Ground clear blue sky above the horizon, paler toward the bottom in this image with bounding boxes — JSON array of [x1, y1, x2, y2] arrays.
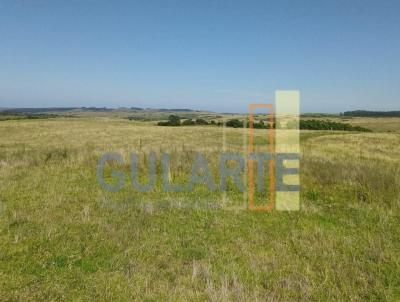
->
[[0, 0, 400, 113]]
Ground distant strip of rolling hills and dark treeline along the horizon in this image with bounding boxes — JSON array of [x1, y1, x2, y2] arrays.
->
[[0, 107, 400, 132]]
